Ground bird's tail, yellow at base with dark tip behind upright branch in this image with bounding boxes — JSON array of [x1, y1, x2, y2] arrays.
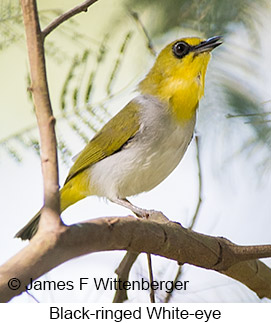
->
[[15, 174, 89, 240]]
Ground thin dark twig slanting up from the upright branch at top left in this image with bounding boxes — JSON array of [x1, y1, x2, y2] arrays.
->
[[42, 0, 98, 38]]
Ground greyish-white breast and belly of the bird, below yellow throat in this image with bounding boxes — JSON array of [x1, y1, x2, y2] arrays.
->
[[90, 96, 195, 199]]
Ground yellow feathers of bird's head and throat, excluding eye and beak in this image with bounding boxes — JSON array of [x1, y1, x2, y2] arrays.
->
[[139, 38, 210, 123]]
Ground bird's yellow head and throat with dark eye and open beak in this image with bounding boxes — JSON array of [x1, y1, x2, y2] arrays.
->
[[139, 36, 222, 118]]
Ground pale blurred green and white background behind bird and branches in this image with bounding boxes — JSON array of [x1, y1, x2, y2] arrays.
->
[[0, 0, 271, 302]]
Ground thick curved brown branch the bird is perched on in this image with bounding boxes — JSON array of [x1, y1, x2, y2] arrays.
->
[[0, 216, 271, 302]]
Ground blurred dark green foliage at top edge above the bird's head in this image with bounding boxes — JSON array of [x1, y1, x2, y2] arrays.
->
[[128, 0, 264, 36]]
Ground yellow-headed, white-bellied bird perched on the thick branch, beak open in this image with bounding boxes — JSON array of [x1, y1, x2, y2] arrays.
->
[[15, 36, 222, 240]]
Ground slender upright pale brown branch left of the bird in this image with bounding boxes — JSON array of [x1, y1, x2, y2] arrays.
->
[[21, 0, 61, 230]]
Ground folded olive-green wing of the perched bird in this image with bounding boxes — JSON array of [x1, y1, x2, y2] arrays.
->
[[65, 101, 139, 184]]
